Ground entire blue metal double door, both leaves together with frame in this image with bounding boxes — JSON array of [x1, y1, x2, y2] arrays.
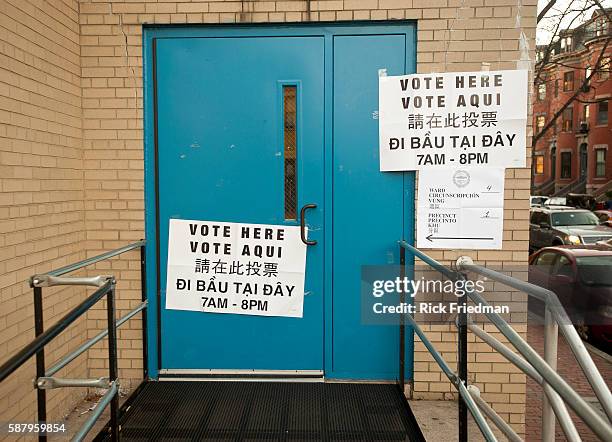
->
[[145, 23, 416, 379]]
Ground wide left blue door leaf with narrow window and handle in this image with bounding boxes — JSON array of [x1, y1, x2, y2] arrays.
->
[[156, 37, 324, 370]]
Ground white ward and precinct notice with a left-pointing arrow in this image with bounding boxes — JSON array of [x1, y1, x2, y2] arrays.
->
[[417, 168, 504, 249]]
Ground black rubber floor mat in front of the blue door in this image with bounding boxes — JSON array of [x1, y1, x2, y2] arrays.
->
[[100, 381, 424, 442]]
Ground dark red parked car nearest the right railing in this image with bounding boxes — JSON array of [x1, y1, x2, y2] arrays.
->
[[529, 245, 612, 345]]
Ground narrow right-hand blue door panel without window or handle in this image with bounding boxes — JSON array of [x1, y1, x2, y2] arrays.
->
[[326, 34, 413, 379]]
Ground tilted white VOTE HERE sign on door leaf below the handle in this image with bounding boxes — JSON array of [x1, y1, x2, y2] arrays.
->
[[166, 219, 306, 318]]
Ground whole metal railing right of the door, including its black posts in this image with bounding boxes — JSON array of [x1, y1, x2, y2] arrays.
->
[[399, 241, 612, 442]]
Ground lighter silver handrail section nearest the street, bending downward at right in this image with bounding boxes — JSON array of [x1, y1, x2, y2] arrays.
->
[[457, 257, 612, 441]]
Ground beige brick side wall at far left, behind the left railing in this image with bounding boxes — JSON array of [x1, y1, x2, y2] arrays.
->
[[0, 0, 91, 428]]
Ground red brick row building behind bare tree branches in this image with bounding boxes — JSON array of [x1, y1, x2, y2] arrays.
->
[[532, 12, 612, 195]]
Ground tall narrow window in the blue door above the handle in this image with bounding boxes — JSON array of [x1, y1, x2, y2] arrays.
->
[[283, 85, 298, 220]]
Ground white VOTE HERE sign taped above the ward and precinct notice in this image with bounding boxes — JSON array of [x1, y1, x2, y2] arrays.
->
[[379, 70, 528, 172]]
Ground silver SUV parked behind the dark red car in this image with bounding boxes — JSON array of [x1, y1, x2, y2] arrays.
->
[[529, 207, 612, 252]]
